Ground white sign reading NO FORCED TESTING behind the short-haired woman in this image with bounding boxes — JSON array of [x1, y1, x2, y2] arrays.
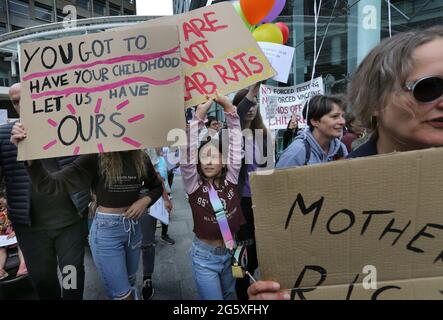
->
[[260, 77, 324, 129]]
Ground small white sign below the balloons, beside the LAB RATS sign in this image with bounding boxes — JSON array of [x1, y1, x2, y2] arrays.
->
[[258, 42, 295, 83]]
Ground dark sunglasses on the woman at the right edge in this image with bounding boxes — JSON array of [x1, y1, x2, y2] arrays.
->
[[406, 76, 443, 103]]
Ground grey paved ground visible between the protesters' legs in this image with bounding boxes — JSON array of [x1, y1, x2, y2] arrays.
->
[[84, 175, 197, 300]]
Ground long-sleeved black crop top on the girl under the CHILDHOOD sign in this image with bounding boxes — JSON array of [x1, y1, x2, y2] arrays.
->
[[27, 152, 163, 208]]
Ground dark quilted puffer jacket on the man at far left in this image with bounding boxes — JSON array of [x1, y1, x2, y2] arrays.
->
[[0, 123, 91, 226]]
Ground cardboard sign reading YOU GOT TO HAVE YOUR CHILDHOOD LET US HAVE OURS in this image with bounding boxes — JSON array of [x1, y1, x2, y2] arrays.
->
[[18, 26, 185, 160]]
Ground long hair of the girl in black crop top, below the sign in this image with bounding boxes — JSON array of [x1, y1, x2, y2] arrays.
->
[[98, 150, 148, 186]]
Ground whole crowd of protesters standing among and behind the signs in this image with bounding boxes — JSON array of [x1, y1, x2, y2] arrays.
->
[[0, 26, 443, 300]]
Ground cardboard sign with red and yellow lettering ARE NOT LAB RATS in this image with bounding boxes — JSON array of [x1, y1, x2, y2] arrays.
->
[[133, 2, 276, 107]]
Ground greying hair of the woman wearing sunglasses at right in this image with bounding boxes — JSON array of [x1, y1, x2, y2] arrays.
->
[[348, 26, 443, 129]]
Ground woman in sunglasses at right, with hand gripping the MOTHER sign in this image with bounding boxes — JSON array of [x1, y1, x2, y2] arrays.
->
[[248, 26, 443, 300]]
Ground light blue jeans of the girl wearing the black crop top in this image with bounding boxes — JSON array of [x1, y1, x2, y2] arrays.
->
[[89, 211, 142, 299]]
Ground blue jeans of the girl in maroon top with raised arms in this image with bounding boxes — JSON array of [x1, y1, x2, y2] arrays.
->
[[190, 237, 235, 300]]
